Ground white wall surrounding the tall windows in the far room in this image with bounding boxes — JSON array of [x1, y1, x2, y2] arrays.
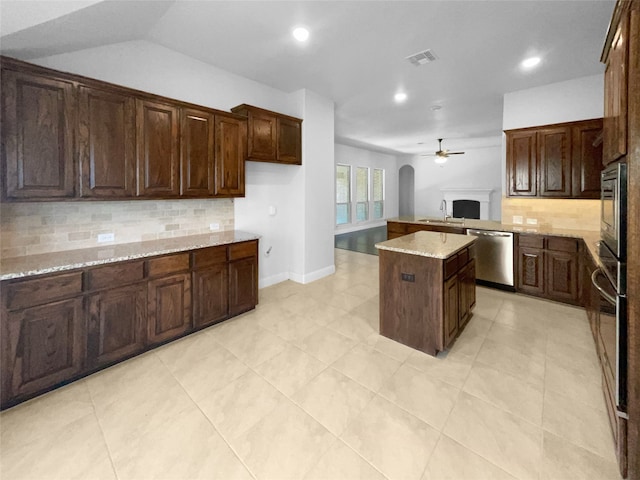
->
[[331, 143, 399, 233]]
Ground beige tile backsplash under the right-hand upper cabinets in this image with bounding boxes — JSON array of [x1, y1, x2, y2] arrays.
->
[[502, 197, 600, 231]]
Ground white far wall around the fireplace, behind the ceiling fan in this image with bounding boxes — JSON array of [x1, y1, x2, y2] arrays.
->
[[408, 144, 502, 220]]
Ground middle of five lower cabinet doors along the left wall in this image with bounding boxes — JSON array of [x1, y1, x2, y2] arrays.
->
[[147, 273, 191, 343]]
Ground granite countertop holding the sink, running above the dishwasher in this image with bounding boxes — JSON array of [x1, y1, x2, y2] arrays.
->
[[387, 215, 601, 266]]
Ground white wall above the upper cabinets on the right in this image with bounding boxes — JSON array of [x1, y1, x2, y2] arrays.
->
[[502, 74, 604, 192]]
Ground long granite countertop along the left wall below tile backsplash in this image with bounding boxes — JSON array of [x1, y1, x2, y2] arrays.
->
[[0, 230, 260, 280]]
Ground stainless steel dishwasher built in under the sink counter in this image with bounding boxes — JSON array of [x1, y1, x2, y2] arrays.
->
[[467, 229, 514, 291]]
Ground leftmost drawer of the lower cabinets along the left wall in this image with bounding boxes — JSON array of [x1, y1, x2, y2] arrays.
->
[[3, 272, 82, 310]]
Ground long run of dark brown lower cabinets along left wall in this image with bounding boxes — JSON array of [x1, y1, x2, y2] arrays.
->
[[0, 240, 258, 408]]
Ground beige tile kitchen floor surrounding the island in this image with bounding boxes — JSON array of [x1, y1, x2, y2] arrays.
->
[[0, 250, 619, 480]]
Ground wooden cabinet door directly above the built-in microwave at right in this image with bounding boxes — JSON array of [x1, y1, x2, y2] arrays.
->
[[603, 13, 629, 165]]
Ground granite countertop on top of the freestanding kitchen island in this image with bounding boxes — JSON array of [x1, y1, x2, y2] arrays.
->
[[376, 232, 476, 260]]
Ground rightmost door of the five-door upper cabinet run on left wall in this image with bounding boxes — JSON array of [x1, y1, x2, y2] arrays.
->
[[215, 115, 247, 197]]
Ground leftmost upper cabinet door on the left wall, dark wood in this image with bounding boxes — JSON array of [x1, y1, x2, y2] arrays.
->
[[2, 70, 75, 199]]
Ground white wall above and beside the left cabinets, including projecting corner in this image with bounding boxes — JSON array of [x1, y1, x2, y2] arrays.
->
[[33, 41, 334, 287]]
